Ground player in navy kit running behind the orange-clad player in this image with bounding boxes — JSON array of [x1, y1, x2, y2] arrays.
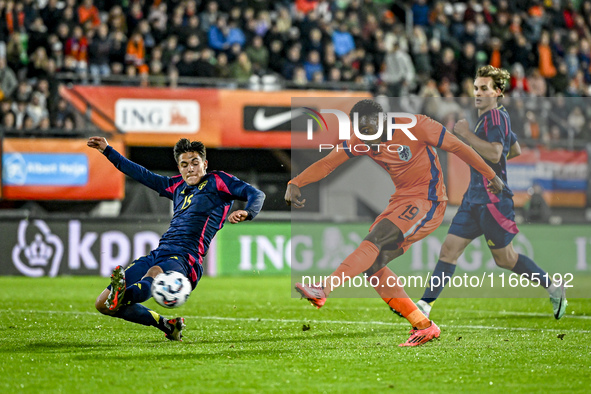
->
[[417, 66, 567, 319]]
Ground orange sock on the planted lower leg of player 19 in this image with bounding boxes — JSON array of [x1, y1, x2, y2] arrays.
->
[[368, 267, 431, 329]]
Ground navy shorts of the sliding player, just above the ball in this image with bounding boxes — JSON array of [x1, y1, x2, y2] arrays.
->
[[107, 249, 203, 289]]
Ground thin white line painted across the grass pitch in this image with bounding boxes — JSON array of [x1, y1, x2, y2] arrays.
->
[[0, 309, 591, 334]]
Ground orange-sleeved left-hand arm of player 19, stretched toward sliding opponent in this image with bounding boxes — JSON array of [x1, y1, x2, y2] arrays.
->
[[285, 145, 349, 208]]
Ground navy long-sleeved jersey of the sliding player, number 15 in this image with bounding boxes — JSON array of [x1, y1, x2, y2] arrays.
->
[[104, 146, 265, 263]]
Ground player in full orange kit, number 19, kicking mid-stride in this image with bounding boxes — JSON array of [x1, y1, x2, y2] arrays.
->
[[285, 99, 504, 346]]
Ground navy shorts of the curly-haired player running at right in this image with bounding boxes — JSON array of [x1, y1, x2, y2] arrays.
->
[[448, 198, 519, 249]]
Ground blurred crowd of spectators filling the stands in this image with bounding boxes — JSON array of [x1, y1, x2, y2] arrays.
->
[[0, 0, 591, 140]]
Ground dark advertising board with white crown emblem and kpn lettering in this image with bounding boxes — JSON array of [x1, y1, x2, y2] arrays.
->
[[0, 219, 169, 277]]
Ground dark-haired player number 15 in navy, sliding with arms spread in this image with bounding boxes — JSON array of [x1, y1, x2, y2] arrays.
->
[[87, 137, 265, 341]]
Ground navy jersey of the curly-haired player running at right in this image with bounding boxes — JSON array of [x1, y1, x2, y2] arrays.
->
[[465, 106, 517, 204]]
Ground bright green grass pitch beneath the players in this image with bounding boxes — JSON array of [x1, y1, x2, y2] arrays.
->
[[0, 277, 591, 393]]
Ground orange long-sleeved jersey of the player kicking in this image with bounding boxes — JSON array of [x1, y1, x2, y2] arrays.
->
[[290, 115, 495, 201]]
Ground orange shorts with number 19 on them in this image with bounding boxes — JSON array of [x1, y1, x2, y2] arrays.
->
[[369, 197, 447, 252]]
